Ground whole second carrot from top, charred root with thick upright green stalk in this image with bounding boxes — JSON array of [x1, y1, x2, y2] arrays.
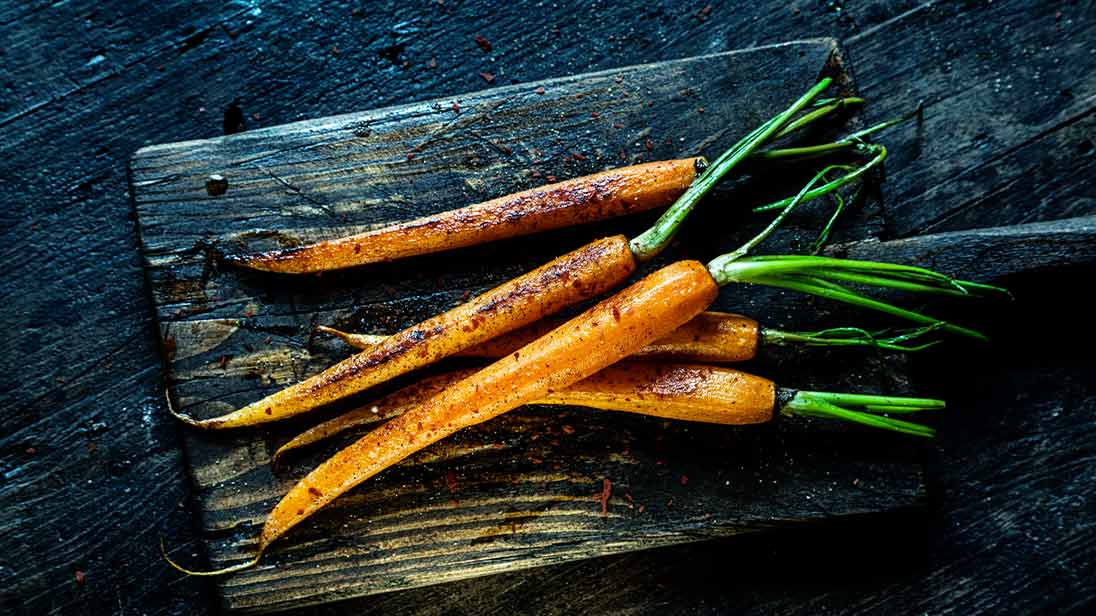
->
[[172, 78, 831, 429]]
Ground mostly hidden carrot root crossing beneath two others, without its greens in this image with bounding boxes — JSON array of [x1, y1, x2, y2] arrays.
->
[[317, 311, 761, 363]]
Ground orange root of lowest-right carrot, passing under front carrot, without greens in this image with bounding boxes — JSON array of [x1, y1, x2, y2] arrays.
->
[[273, 362, 776, 460]]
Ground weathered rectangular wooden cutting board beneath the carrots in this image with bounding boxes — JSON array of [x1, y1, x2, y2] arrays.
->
[[130, 39, 923, 611]]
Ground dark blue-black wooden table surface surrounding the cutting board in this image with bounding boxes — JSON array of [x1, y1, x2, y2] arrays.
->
[[0, 0, 1096, 614]]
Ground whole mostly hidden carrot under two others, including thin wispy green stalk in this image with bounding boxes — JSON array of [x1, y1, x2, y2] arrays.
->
[[316, 311, 937, 363]]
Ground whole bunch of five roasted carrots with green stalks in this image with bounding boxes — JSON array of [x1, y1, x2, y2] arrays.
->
[[168, 79, 1006, 575]]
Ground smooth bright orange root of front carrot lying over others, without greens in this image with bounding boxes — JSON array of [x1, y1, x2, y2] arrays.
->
[[259, 261, 719, 554]]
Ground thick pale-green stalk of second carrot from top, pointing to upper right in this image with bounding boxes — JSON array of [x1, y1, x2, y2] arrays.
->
[[630, 78, 832, 261]]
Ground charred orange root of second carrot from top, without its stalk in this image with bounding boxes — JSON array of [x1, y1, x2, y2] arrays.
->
[[176, 236, 636, 429]]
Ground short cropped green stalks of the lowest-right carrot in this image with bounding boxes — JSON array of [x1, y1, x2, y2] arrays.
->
[[780, 391, 945, 437]]
